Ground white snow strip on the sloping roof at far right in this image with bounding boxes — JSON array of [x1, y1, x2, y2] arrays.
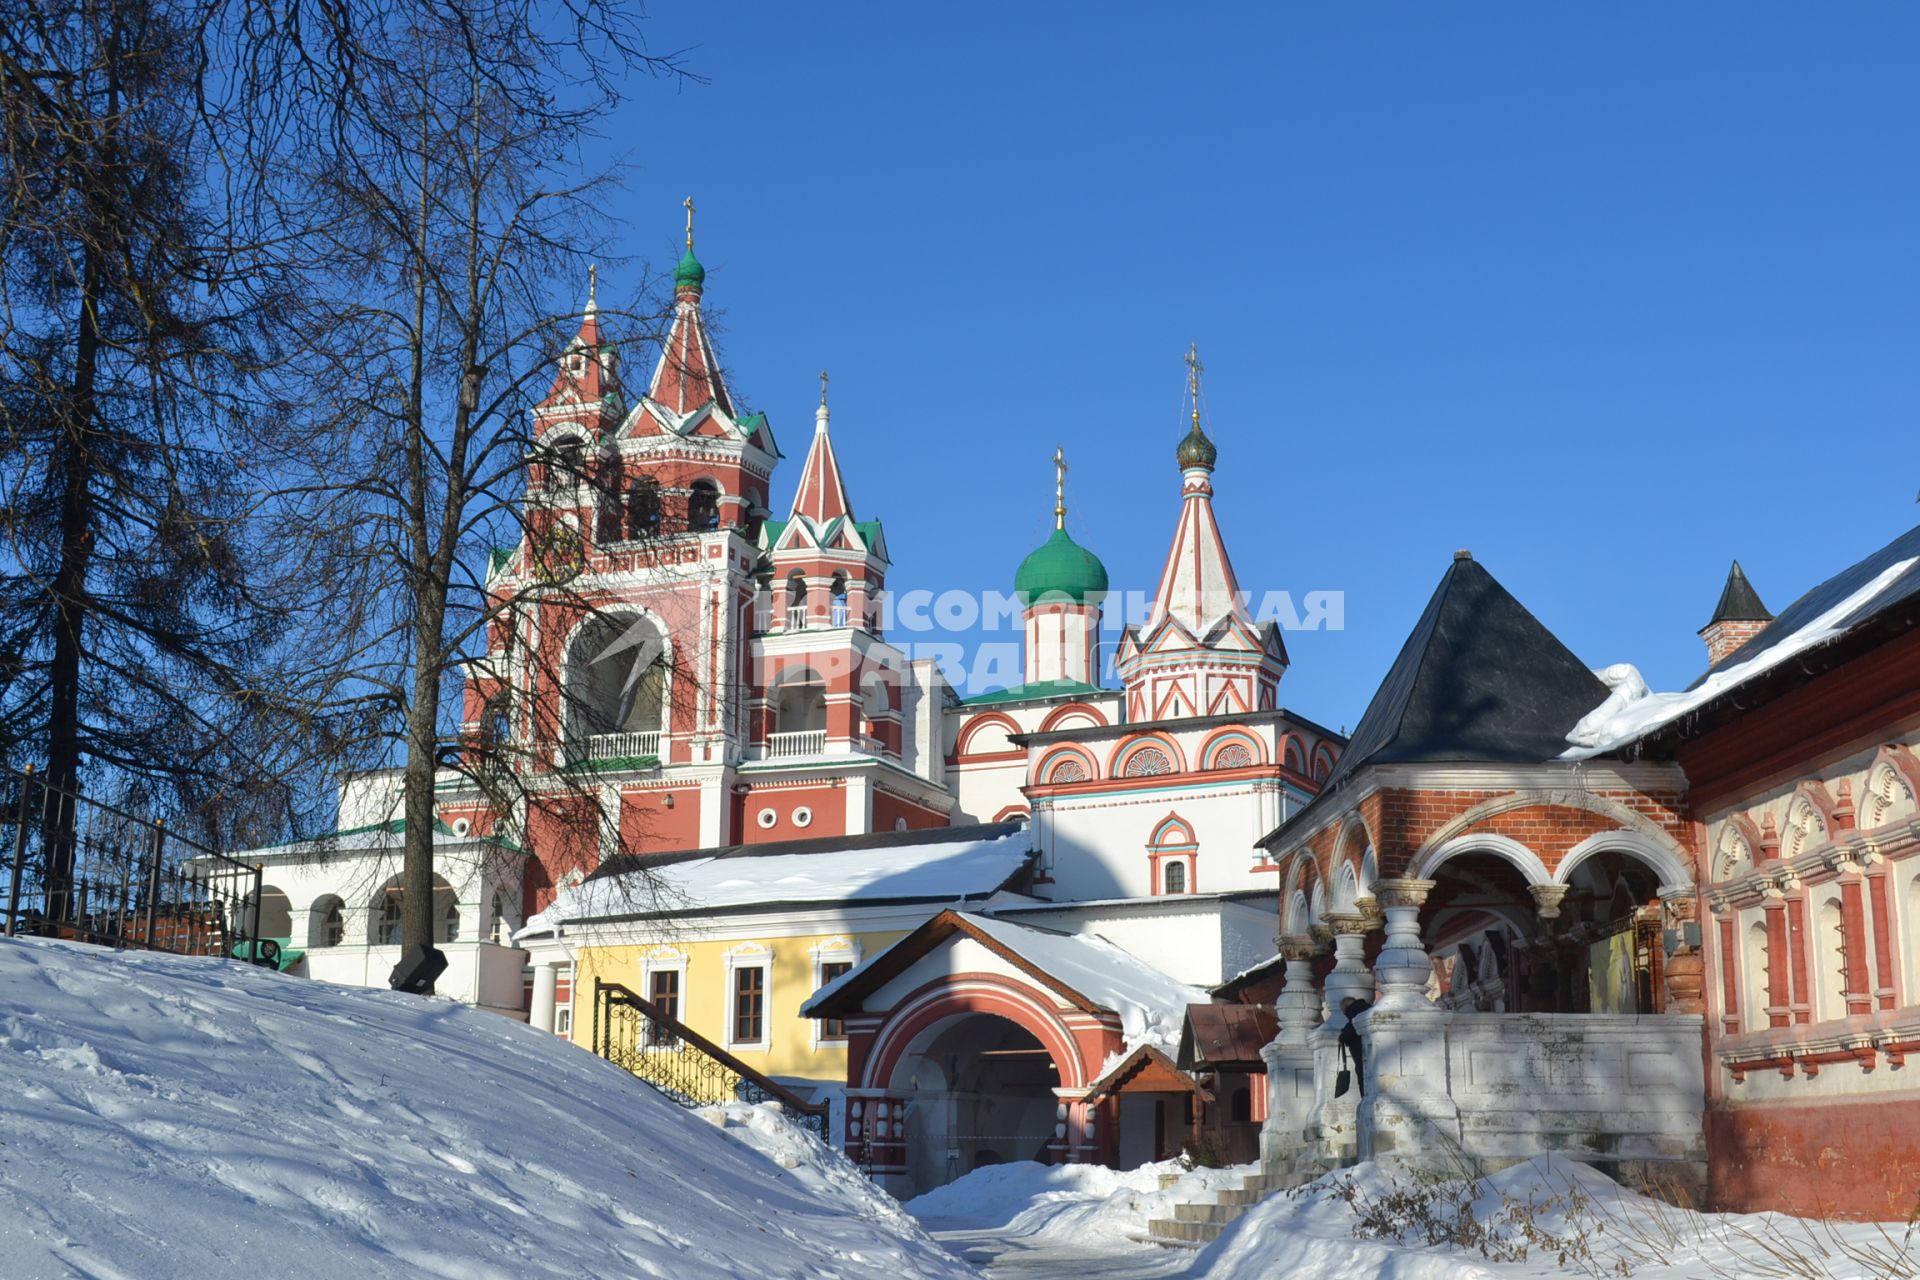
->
[[1561, 557, 1920, 760]]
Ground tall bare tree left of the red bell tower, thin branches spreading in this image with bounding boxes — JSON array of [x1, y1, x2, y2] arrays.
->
[[245, 0, 698, 946]]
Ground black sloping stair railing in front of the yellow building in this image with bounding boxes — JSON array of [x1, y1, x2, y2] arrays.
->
[[593, 979, 828, 1142]]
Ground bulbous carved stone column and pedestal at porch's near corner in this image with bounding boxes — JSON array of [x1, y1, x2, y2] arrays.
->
[[1356, 879, 1461, 1169]]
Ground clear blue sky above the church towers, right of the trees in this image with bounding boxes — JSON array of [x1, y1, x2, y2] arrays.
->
[[576, 0, 1920, 725]]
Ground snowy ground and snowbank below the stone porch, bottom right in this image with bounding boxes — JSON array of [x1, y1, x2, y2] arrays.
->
[[906, 1157, 1920, 1280]]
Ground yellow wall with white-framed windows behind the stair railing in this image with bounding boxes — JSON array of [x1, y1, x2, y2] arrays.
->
[[570, 931, 904, 1084]]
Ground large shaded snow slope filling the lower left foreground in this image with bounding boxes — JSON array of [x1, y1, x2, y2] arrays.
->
[[0, 940, 975, 1280]]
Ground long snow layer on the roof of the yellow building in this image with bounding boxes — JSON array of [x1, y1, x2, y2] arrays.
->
[[516, 827, 1029, 936]]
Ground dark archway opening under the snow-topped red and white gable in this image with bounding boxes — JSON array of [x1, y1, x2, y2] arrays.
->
[[887, 1013, 1060, 1196]]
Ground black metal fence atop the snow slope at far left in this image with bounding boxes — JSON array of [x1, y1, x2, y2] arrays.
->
[[0, 770, 264, 963]]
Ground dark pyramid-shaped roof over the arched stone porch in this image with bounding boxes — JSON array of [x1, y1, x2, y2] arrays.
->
[[1302, 551, 1607, 812]]
